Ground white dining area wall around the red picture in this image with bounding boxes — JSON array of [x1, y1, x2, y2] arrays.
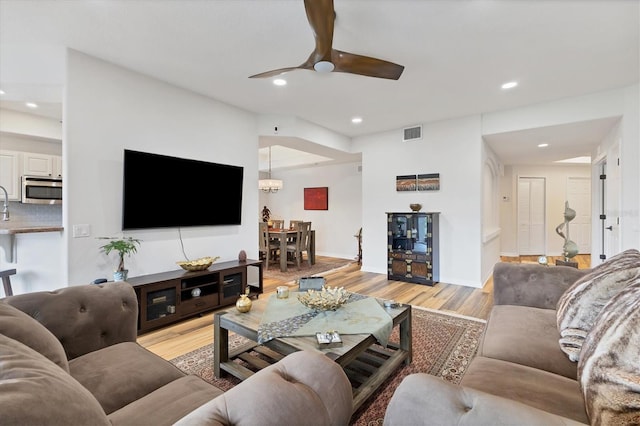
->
[[256, 163, 363, 259]]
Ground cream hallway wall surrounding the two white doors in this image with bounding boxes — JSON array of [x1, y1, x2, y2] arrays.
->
[[500, 165, 593, 256]]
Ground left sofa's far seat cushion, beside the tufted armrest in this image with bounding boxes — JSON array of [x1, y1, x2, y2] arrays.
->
[[69, 342, 185, 414]]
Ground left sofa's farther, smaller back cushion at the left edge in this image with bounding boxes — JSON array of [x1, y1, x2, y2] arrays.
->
[[0, 302, 69, 373]]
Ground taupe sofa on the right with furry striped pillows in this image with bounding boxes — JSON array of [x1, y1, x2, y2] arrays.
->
[[384, 250, 640, 426]]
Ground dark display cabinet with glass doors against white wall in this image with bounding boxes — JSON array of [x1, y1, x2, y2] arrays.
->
[[387, 212, 440, 285]]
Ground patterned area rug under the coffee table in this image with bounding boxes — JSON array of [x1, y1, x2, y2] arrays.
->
[[171, 307, 485, 426]]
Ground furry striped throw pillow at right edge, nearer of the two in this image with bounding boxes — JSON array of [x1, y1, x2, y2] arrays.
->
[[578, 278, 640, 425]]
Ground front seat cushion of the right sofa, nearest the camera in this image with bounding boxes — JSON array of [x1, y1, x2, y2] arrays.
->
[[462, 356, 588, 423]]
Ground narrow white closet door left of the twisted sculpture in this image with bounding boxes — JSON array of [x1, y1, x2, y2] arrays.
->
[[518, 177, 546, 255]]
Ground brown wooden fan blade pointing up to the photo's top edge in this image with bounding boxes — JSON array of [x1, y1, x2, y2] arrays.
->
[[304, 0, 336, 63]]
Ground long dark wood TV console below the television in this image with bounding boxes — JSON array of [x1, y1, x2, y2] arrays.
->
[[127, 260, 263, 334]]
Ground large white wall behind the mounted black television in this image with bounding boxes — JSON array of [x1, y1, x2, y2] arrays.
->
[[61, 50, 258, 288]]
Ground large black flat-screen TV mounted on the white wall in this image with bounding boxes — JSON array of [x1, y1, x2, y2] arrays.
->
[[122, 149, 244, 230]]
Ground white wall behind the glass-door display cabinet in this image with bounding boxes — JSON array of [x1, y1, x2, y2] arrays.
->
[[353, 116, 482, 287]]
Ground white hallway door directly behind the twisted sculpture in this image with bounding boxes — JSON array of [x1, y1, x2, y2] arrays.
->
[[567, 177, 591, 254]]
